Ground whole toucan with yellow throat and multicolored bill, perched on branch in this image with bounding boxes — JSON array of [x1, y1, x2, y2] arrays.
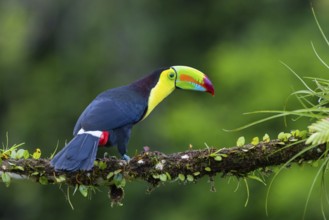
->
[[50, 66, 215, 172]]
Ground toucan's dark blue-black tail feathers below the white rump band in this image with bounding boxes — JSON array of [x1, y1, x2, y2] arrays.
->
[[50, 133, 99, 171]]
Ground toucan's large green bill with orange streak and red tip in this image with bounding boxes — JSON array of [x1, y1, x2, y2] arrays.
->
[[171, 66, 215, 95]]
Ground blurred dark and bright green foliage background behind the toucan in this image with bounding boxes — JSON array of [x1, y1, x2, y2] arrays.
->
[[0, 0, 329, 220]]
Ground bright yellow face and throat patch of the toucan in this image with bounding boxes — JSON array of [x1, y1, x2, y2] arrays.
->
[[142, 69, 176, 120]]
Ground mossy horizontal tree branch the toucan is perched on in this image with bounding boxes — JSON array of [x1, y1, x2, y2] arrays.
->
[[0, 137, 326, 205]]
